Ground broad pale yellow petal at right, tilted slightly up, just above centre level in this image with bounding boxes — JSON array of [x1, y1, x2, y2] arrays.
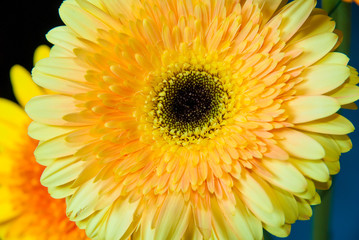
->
[[296, 64, 350, 95]]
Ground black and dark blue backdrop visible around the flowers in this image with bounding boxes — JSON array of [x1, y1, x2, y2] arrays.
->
[[0, 0, 359, 240]]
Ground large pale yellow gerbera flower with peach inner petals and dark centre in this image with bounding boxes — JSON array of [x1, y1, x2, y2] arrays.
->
[[26, 0, 359, 240]]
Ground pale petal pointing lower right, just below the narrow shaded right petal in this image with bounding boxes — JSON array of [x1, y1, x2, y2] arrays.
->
[[275, 129, 325, 160]]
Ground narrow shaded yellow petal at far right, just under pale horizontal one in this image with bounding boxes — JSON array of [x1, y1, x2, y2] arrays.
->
[[295, 114, 354, 135]]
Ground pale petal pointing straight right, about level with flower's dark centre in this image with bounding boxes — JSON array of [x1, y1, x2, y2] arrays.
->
[[283, 96, 340, 123]]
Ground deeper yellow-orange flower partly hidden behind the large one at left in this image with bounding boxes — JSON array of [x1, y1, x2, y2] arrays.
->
[[0, 46, 87, 240]]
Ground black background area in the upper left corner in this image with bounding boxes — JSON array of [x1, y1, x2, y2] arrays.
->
[[0, 0, 63, 100]]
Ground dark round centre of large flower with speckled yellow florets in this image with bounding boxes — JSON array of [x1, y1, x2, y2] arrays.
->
[[147, 67, 230, 145]]
